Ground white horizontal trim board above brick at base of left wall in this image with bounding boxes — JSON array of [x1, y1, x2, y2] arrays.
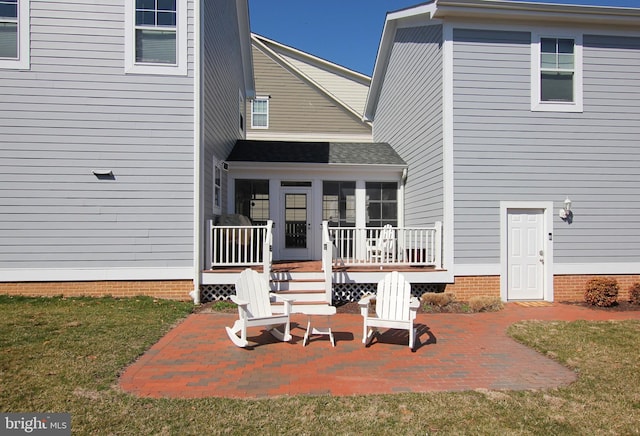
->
[[0, 266, 193, 282]]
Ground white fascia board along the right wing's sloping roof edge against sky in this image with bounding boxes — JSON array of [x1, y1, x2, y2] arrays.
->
[[363, 3, 436, 121]]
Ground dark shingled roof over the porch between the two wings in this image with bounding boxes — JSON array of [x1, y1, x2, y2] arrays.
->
[[227, 139, 407, 168]]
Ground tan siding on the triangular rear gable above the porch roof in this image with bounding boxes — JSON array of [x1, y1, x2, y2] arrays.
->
[[247, 46, 371, 134]]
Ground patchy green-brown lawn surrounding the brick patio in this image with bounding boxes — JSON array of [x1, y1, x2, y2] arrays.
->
[[0, 297, 640, 435]]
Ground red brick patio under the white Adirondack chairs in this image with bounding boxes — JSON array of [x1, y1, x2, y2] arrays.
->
[[120, 304, 640, 398]]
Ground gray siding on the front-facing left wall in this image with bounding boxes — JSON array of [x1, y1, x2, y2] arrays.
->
[[0, 0, 194, 270]]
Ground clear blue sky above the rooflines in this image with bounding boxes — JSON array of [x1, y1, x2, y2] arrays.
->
[[249, 0, 640, 75]]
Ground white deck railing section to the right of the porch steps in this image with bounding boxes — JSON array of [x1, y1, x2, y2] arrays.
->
[[323, 222, 442, 269]]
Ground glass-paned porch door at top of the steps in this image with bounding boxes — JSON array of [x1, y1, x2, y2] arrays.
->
[[278, 187, 314, 260]]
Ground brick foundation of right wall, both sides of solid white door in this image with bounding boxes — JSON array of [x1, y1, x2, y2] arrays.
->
[[445, 275, 640, 302]]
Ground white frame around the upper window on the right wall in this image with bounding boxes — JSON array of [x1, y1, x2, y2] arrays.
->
[[531, 31, 583, 112]]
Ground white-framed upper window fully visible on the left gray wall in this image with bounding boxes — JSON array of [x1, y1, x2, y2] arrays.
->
[[125, 0, 187, 75]]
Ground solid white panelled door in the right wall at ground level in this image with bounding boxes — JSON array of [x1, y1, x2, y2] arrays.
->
[[507, 209, 545, 300]]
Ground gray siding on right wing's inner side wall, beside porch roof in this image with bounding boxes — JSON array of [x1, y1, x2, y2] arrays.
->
[[373, 26, 443, 226]]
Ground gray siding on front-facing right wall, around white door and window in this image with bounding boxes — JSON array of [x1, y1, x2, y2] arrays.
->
[[454, 29, 640, 264]]
